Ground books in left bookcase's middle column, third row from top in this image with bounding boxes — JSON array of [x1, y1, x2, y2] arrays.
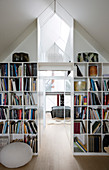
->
[[10, 93, 22, 105]]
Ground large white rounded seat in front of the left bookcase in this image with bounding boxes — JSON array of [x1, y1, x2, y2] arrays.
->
[[0, 142, 33, 168]]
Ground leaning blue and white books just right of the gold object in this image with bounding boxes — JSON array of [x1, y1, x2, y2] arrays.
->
[[89, 79, 101, 91]]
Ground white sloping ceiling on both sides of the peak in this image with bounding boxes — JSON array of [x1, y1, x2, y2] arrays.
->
[[0, 0, 109, 58]]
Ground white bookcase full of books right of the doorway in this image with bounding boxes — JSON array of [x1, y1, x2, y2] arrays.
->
[[73, 62, 109, 155]]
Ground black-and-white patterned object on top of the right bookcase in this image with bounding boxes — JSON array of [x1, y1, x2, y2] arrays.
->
[[77, 52, 99, 62]]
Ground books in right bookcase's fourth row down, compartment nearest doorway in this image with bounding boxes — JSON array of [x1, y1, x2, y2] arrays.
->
[[74, 107, 87, 119]]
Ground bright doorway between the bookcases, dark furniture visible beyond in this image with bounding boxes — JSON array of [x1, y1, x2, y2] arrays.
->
[[39, 66, 72, 145]]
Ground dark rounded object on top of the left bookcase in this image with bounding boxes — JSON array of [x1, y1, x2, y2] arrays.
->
[[12, 52, 29, 62]]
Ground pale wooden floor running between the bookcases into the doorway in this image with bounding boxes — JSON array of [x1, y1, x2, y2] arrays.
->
[[0, 113, 109, 170]]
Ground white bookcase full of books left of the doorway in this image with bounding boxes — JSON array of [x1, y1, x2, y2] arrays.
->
[[0, 62, 38, 155]]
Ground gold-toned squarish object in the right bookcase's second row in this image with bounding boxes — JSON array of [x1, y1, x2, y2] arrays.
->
[[74, 81, 86, 91]]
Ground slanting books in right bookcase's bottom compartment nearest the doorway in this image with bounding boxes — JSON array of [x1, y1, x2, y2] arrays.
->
[[74, 136, 87, 152]]
